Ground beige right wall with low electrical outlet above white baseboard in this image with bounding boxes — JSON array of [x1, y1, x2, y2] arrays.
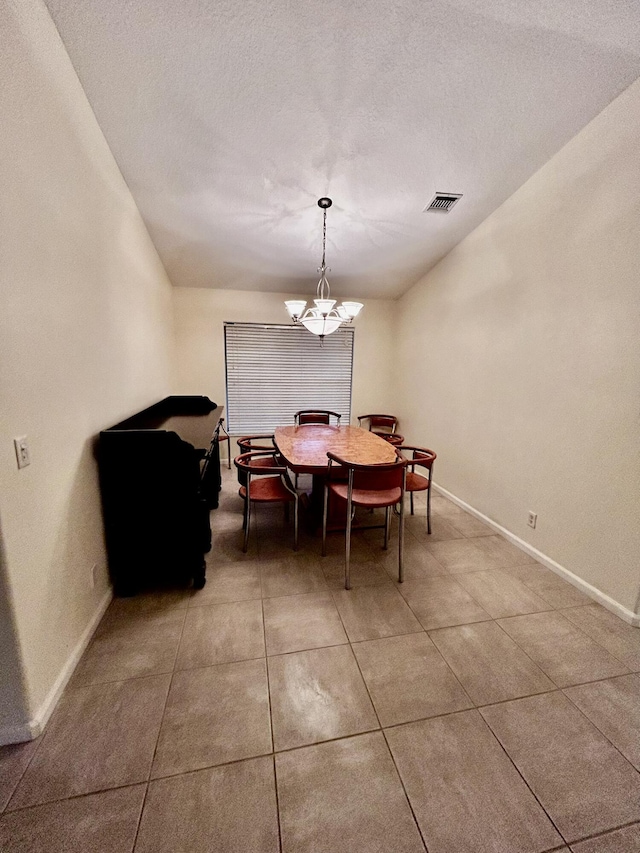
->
[[396, 81, 640, 618]]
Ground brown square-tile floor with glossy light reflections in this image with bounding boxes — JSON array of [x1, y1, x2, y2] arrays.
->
[[0, 469, 640, 853]]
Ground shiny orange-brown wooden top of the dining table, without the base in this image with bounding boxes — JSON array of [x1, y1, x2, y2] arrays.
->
[[274, 424, 396, 474]]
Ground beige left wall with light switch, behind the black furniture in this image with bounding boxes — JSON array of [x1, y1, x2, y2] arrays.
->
[[0, 0, 173, 739]]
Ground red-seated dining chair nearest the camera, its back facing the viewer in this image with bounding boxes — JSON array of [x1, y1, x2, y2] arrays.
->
[[322, 452, 407, 589]]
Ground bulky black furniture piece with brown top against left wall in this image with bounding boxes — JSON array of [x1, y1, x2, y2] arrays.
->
[[98, 396, 223, 595]]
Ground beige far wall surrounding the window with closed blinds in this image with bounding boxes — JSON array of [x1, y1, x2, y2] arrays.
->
[[173, 288, 395, 442]]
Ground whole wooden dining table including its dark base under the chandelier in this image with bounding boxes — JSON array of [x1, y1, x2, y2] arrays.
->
[[274, 424, 397, 530]]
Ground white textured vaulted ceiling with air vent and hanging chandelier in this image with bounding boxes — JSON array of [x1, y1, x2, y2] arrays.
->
[[47, 0, 640, 297]]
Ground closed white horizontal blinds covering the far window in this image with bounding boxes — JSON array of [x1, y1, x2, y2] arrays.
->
[[224, 323, 354, 435]]
